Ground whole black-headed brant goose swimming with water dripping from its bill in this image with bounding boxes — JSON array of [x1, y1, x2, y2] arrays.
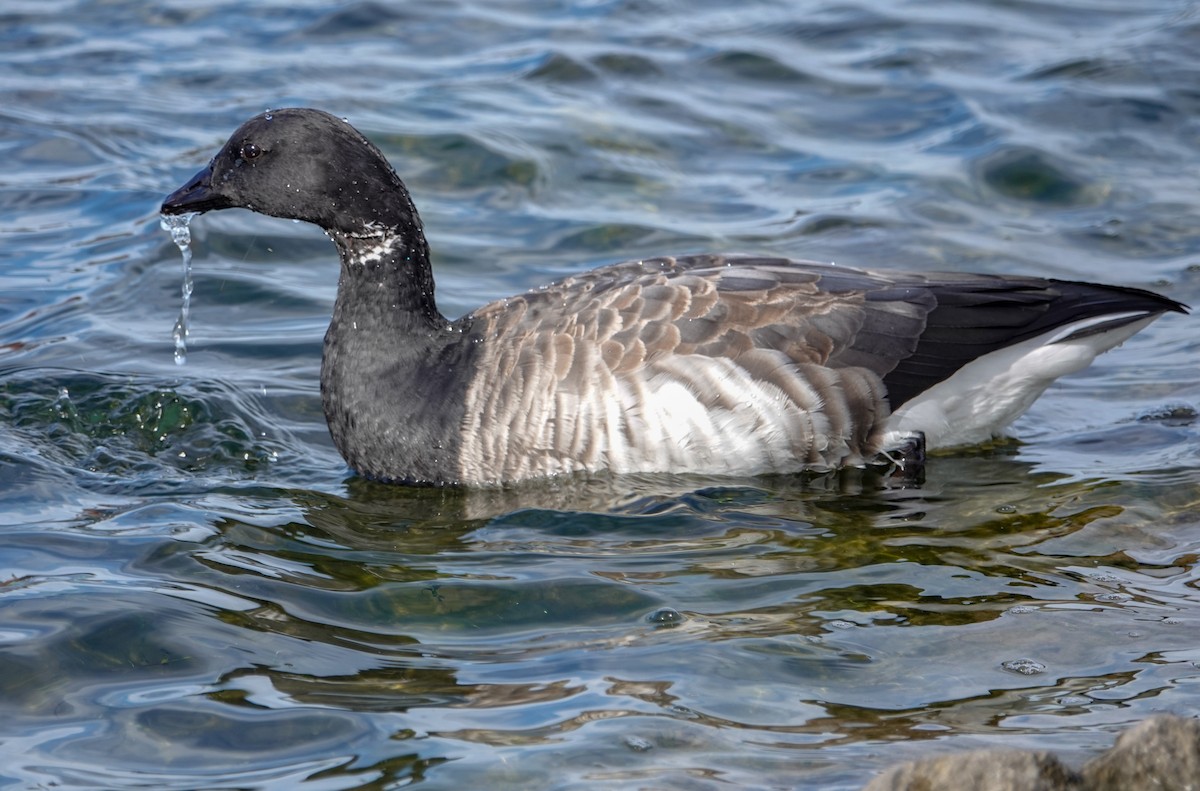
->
[[162, 109, 1187, 486]]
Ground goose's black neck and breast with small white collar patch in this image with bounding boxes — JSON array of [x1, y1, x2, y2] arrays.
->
[[320, 220, 478, 484]]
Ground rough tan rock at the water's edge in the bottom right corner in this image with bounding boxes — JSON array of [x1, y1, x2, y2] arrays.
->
[[863, 715, 1200, 791]]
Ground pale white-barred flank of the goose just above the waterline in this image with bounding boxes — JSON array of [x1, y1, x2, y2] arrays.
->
[[453, 352, 862, 483]]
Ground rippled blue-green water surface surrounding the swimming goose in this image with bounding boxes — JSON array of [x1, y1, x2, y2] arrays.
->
[[0, 0, 1200, 791]]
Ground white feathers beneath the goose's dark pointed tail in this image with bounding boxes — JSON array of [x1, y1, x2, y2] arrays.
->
[[883, 314, 1158, 449]]
